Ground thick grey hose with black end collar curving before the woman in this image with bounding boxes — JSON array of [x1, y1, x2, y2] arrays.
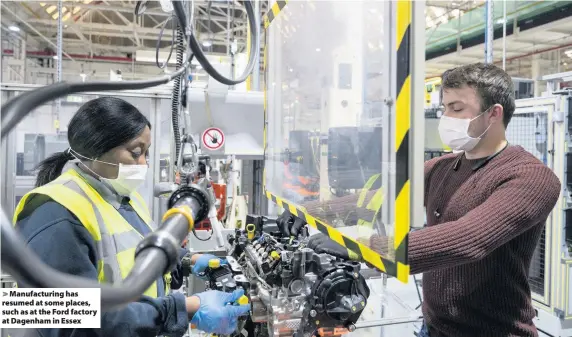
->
[[0, 181, 210, 312]]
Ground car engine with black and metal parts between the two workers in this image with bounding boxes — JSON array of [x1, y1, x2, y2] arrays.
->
[[206, 222, 370, 337]]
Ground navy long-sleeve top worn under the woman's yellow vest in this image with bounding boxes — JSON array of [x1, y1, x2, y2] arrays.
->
[[16, 168, 189, 337]]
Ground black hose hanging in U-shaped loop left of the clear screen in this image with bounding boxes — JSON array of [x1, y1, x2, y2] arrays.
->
[[173, 0, 260, 85]]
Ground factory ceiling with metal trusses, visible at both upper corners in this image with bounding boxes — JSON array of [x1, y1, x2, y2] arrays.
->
[[1, 0, 572, 77]]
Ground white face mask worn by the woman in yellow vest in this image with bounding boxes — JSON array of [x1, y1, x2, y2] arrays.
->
[[70, 150, 148, 196]]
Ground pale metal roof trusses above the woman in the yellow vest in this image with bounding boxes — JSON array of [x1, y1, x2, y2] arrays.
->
[[2, 0, 268, 56]]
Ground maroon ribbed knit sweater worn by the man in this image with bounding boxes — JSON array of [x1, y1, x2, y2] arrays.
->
[[409, 146, 561, 337]]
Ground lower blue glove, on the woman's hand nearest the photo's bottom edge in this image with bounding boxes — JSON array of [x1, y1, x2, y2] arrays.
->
[[191, 289, 250, 335]]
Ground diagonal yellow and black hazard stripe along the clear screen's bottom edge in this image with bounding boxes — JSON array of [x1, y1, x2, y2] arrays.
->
[[265, 191, 398, 276]]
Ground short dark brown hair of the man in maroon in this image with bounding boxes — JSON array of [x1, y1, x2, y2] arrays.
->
[[441, 63, 515, 128]]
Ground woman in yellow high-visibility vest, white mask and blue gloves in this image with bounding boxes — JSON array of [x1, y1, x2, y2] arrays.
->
[[14, 97, 249, 337]]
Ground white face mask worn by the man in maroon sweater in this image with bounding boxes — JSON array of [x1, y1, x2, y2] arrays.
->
[[439, 109, 492, 151]]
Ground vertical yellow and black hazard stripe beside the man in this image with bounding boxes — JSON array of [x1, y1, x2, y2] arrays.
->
[[394, 0, 413, 282]]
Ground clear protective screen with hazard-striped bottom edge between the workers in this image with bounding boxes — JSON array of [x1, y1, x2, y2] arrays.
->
[[264, 1, 409, 275]]
